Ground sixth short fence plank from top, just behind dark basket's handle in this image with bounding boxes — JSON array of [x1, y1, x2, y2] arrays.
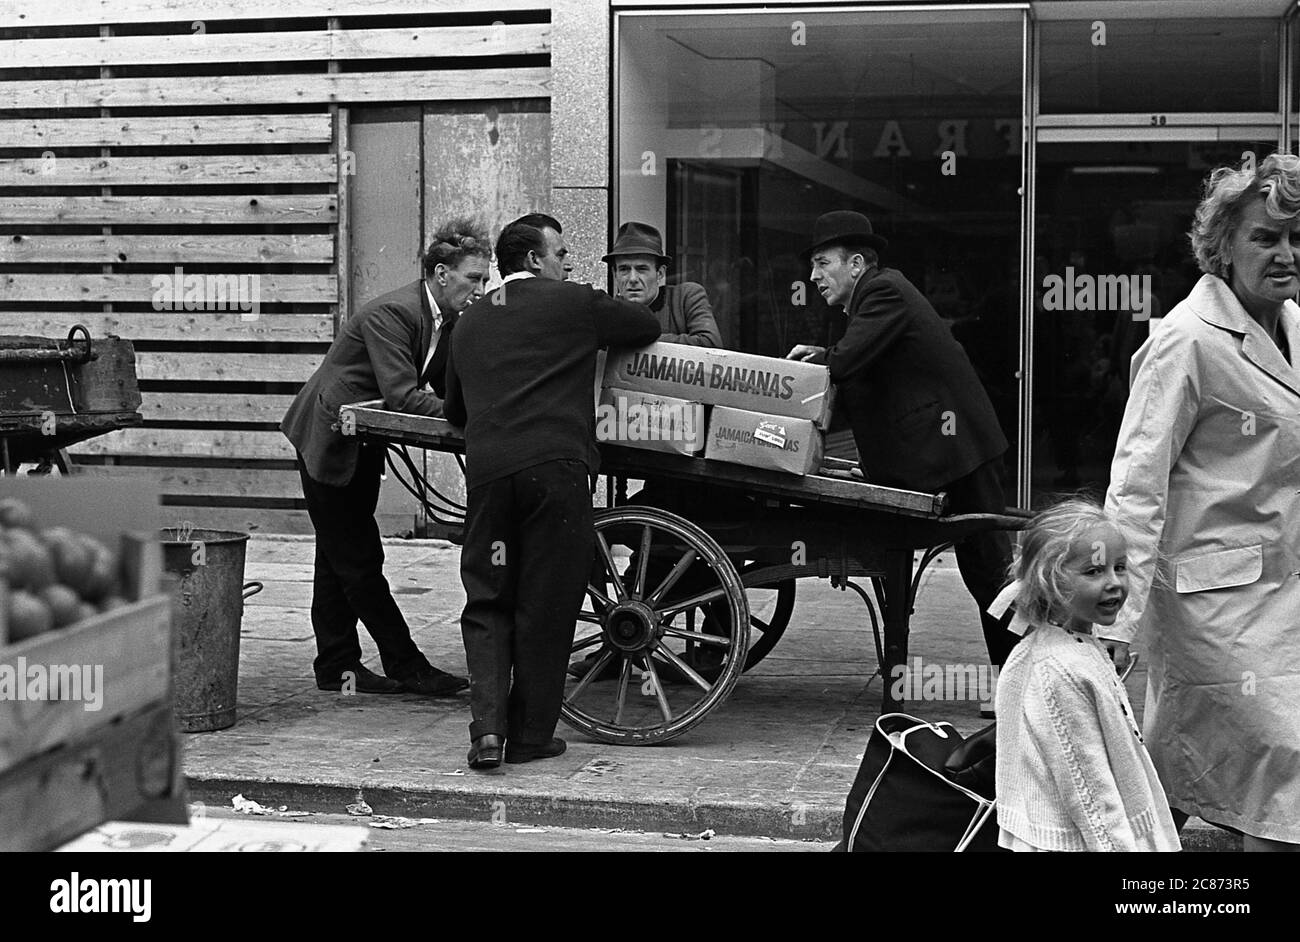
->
[[0, 311, 334, 343]]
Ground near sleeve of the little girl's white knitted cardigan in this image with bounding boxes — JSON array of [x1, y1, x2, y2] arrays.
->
[[1026, 657, 1139, 851]]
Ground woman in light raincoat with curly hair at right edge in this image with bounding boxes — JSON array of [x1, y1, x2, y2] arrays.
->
[[1104, 155, 1300, 850]]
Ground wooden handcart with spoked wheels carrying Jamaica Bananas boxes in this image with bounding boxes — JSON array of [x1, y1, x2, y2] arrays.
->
[[339, 403, 1027, 745]]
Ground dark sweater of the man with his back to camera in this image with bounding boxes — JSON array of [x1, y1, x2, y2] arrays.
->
[[445, 278, 659, 489]]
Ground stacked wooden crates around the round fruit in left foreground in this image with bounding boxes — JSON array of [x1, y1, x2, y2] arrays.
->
[[0, 477, 187, 851]]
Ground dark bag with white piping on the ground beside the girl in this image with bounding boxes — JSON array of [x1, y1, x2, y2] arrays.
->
[[836, 713, 1001, 851]]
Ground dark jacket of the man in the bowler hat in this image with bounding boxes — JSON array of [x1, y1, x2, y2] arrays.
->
[[815, 261, 1008, 491]]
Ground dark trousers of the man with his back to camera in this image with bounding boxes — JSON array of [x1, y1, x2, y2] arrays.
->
[[460, 461, 595, 746]]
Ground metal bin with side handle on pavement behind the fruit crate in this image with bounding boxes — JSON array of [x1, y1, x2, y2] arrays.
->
[[163, 526, 261, 733]]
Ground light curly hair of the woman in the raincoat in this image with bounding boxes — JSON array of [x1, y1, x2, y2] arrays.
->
[[1190, 153, 1300, 281]]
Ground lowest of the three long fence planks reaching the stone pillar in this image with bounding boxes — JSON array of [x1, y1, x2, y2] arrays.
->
[[0, 66, 551, 109]]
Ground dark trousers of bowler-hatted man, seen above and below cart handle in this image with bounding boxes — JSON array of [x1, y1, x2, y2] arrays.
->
[[940, 457, 1019, 667]]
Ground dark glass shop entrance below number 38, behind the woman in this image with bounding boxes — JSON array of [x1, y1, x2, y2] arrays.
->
[[1031, 139, 1277, 504]]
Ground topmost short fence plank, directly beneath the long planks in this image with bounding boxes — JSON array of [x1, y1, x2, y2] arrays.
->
[[0, 112, 334, 148]]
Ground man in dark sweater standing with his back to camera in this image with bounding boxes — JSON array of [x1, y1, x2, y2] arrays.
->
[[443, 217, 659, 769]]
